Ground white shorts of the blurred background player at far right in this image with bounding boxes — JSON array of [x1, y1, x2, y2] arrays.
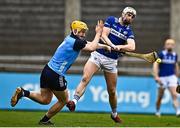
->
[[158, 75, 178, 88]]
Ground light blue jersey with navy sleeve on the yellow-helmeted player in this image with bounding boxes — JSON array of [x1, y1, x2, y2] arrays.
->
[[48, 34, 87, 76]]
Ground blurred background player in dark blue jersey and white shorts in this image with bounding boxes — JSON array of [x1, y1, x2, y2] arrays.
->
[[153, 39, 180, 117]]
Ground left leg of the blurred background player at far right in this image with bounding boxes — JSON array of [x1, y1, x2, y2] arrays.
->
[[156, 87, 165, 117]]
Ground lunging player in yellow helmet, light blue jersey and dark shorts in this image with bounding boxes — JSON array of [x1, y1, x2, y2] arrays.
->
[[11, 21, 111, 125]]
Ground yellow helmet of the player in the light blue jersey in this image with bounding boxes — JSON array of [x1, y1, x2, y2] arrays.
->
[[71, 20, 88, 32]]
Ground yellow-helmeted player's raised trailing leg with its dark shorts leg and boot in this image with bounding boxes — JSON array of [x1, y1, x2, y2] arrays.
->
[[11, 65, 55, 107]]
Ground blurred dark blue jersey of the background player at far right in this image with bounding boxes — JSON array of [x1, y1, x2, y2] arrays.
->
[[158, 50, 178, 76]]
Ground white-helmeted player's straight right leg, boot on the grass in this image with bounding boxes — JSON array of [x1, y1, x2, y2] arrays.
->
[[104, 71, 122, 123]]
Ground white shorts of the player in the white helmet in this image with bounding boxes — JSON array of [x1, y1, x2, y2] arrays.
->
[[89, 51, 118, 73]]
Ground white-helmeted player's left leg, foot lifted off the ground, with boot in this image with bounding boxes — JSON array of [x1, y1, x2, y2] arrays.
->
[[67, 60, 99, 111]]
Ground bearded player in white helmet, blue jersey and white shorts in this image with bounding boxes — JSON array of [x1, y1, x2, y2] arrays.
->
[[67, 7, 136, 123]]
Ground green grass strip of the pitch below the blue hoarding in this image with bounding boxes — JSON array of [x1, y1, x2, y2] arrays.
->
[[0, 110, 180, 127]]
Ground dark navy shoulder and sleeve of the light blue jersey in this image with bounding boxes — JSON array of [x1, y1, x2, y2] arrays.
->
[[70, 33, 87, 51]]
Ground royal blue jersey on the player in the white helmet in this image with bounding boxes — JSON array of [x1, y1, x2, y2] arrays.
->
[[97, 16, 134, 59]]
